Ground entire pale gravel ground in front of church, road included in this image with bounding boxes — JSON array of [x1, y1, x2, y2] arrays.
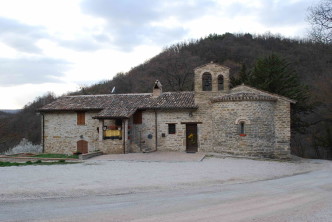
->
[[0, 158, 332, 222]]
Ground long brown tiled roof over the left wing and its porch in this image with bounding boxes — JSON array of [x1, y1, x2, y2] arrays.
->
[[39, 92, 197, 118]]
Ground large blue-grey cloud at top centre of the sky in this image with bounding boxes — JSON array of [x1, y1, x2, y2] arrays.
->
[[81, 0, 214, 50]]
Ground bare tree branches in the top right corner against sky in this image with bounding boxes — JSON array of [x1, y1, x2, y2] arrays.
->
[[307, 0, 332, 44]]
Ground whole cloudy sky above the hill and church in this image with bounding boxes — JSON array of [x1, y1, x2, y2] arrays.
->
[[0, 0, 318, 109]]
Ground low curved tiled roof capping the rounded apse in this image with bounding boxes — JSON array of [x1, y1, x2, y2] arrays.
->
[[211, 92, 277, 102]]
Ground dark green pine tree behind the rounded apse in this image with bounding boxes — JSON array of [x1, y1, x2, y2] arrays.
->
[[239, 54, 314, 133]]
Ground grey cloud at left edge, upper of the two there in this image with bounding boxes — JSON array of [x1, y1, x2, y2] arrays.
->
[[0, 17, 48, 53]]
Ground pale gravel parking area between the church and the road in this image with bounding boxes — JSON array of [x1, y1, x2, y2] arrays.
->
[[0, 154, 325, 201]]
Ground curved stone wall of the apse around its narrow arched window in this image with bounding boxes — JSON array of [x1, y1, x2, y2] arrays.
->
[[212, 101, 275, 157]]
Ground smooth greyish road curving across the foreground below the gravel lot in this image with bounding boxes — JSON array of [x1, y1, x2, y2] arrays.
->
[[0, 168, 332, 222]]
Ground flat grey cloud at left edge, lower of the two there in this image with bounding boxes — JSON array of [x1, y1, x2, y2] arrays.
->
[[0, 58, 69, 86]]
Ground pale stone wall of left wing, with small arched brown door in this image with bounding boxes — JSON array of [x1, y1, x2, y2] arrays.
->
[[44, 112, 123, 154]]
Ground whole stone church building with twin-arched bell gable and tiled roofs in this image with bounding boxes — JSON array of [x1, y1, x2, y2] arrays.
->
[[39, 63, 295, 158]]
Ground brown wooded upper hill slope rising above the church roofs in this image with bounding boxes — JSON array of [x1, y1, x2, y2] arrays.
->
[[73, 33, 332, 97]]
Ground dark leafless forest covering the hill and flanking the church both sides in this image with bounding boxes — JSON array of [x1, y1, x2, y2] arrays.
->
[[0, 33, 332, 159]]
